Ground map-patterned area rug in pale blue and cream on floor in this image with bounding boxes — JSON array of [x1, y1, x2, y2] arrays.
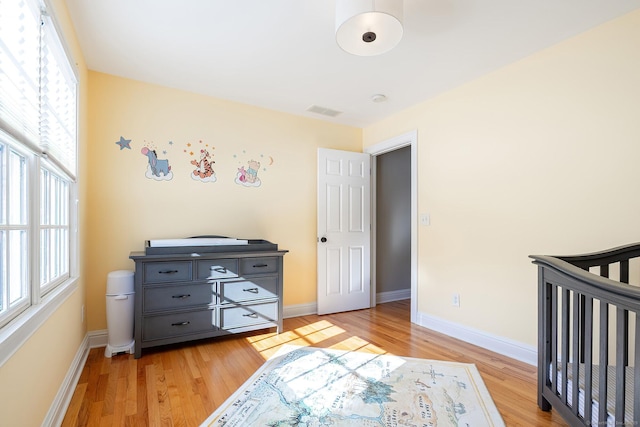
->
[[202, 346, 504, 427]]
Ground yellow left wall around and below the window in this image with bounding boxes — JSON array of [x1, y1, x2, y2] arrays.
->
[[0, 0, 87, 427]]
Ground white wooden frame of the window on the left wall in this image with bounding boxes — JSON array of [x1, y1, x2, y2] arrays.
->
[[0, 2, 79, 366]]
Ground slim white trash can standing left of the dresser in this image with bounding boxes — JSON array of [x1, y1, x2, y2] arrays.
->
[[104, 270, 135, 357]]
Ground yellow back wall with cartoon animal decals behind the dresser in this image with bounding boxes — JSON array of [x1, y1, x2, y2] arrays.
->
[[85, 72, 362, 330]]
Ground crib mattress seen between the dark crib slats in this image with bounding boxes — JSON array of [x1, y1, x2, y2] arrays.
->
[[549, 363, 633, 427]]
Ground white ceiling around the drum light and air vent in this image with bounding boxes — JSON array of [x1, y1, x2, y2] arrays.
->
[[66, 0, 640, 127]]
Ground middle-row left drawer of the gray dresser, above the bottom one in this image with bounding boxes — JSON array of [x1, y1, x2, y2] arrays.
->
[[142, 283, 215, 313]]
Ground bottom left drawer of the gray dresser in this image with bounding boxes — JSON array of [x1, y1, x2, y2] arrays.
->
[[142, 310, 215, 341]]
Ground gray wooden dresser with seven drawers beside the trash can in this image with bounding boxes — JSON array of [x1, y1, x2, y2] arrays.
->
[[129, 240, 287, 359]]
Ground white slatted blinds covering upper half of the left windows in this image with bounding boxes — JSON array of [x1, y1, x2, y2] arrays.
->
[[0, 0, 77, 179]]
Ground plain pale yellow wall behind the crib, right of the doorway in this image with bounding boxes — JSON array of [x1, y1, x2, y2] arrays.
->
[[363, 12, 640, 345]]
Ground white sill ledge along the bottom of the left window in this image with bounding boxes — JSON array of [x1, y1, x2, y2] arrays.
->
[[0, 277, 78, 367]]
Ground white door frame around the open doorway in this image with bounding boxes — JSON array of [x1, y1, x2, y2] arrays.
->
[[364, 130, 418, 323]]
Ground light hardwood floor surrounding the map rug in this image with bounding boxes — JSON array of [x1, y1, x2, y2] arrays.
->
[[63, 300, 567, 426]]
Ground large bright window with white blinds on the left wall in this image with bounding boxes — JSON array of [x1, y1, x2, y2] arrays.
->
[[0, 0, 77, 327]]
